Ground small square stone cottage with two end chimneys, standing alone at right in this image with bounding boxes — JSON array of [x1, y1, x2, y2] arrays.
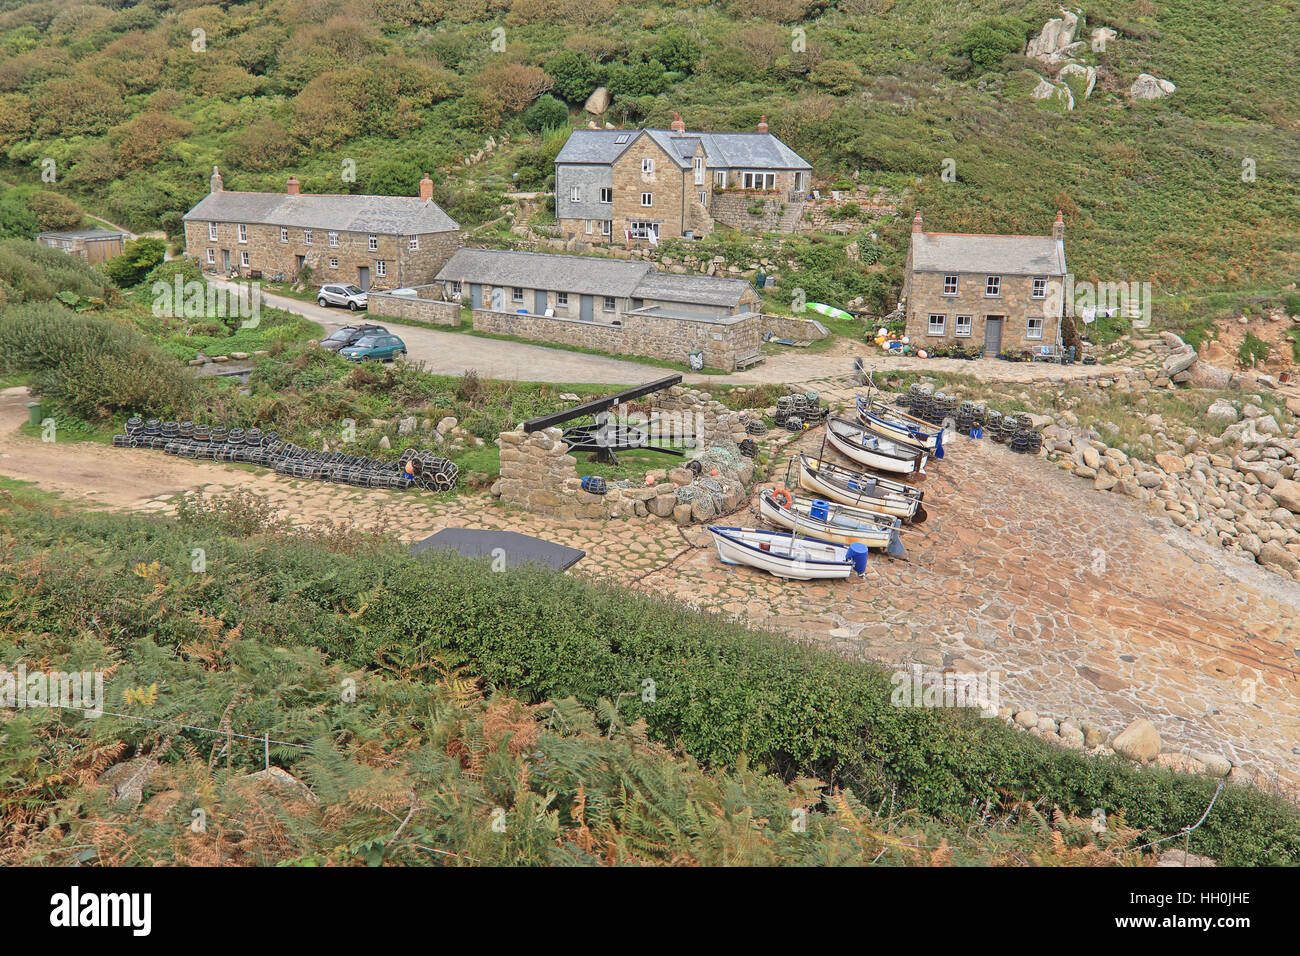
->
[[901, 212, 1067, 355]]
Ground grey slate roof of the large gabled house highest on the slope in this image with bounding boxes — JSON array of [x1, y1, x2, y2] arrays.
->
[[555, 129, 813, 169]]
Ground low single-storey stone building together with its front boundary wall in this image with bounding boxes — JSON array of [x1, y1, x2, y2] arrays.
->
[[438, 248, 766, 371]]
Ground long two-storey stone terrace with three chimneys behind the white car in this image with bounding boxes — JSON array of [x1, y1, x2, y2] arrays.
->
[[185, 166, 462, 289]]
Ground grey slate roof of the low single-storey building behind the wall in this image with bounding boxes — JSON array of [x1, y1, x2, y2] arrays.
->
[[437, 247, 751, 308]]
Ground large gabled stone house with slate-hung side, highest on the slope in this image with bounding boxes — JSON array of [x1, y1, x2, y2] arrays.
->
[[555, 114, 813, 246]]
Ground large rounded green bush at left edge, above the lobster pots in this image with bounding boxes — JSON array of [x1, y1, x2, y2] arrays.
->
[[0, 303, 195, 423]]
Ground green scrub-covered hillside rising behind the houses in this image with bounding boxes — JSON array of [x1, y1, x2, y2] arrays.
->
[[0, 0, 1300, 325]]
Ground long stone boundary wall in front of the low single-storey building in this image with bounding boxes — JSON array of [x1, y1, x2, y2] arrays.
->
[[473, 308, 763, 372]]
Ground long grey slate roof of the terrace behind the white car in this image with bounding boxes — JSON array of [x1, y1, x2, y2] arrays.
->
[[185, 190, 460, 235]]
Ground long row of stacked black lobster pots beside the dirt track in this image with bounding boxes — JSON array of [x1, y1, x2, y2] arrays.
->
[[113, 418, 460, 492]]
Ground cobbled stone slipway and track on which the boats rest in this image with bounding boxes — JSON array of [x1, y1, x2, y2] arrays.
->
[[0, 390, 1300, 793]]
